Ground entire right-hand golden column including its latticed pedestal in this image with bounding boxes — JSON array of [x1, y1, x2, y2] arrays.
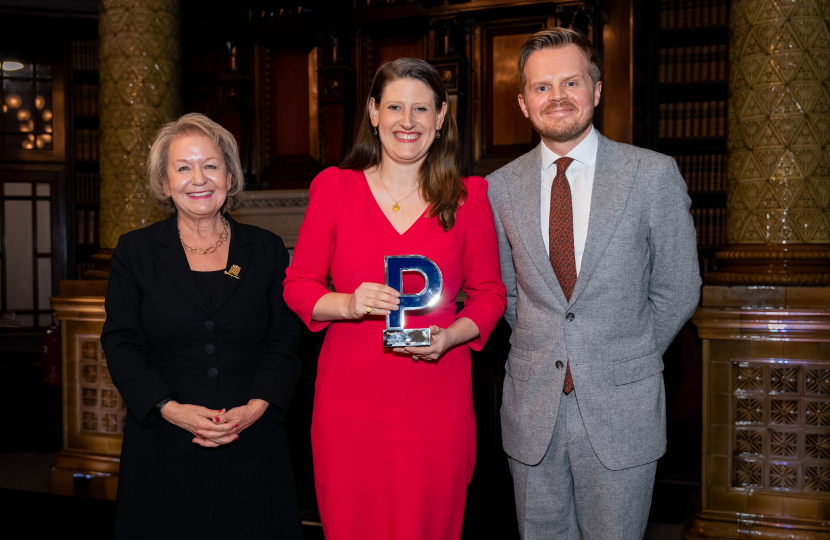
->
[[684, 0, 830, 540]]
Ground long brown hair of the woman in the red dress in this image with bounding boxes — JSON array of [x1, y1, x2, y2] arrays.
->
[[340, 58, 467, 232]]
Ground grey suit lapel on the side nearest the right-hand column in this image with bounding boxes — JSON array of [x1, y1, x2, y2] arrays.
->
[[571, 133, 638, 304]]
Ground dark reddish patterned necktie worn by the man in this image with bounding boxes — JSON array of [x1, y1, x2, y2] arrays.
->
[[548, 158, 576, 394]]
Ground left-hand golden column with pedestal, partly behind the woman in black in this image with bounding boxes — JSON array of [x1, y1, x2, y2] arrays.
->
[[50, 0, 182, 499]]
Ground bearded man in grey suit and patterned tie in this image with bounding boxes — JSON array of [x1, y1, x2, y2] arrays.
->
[[488, 28, 700, 540]]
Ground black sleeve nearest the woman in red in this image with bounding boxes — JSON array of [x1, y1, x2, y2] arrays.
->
[[249, 237, 303, 420]]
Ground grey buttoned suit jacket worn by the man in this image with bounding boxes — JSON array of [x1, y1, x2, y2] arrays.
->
[[487, 135, 701, 470]]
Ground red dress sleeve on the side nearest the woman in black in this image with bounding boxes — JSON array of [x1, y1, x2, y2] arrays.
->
[[283, 167, 340, 332]]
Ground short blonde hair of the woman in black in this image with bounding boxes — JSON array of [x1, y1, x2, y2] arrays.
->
[[147, 113, 245, 214]]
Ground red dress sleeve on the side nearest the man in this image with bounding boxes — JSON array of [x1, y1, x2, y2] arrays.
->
[[456, 177, 507, 351]]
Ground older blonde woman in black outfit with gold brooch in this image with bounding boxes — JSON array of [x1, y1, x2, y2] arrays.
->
[[101, 114, 302, 539]]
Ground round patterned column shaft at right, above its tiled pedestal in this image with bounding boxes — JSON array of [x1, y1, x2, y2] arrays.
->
[[709, 0, 830, 286]]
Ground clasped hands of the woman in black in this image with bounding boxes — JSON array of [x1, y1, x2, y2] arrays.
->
[[161, 399, 268, 448]]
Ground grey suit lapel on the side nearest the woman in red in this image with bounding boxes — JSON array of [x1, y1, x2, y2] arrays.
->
[[510, 146, 568, 307]]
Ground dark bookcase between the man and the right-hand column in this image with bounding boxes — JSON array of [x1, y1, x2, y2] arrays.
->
[[634, 0, 729, 279]]
